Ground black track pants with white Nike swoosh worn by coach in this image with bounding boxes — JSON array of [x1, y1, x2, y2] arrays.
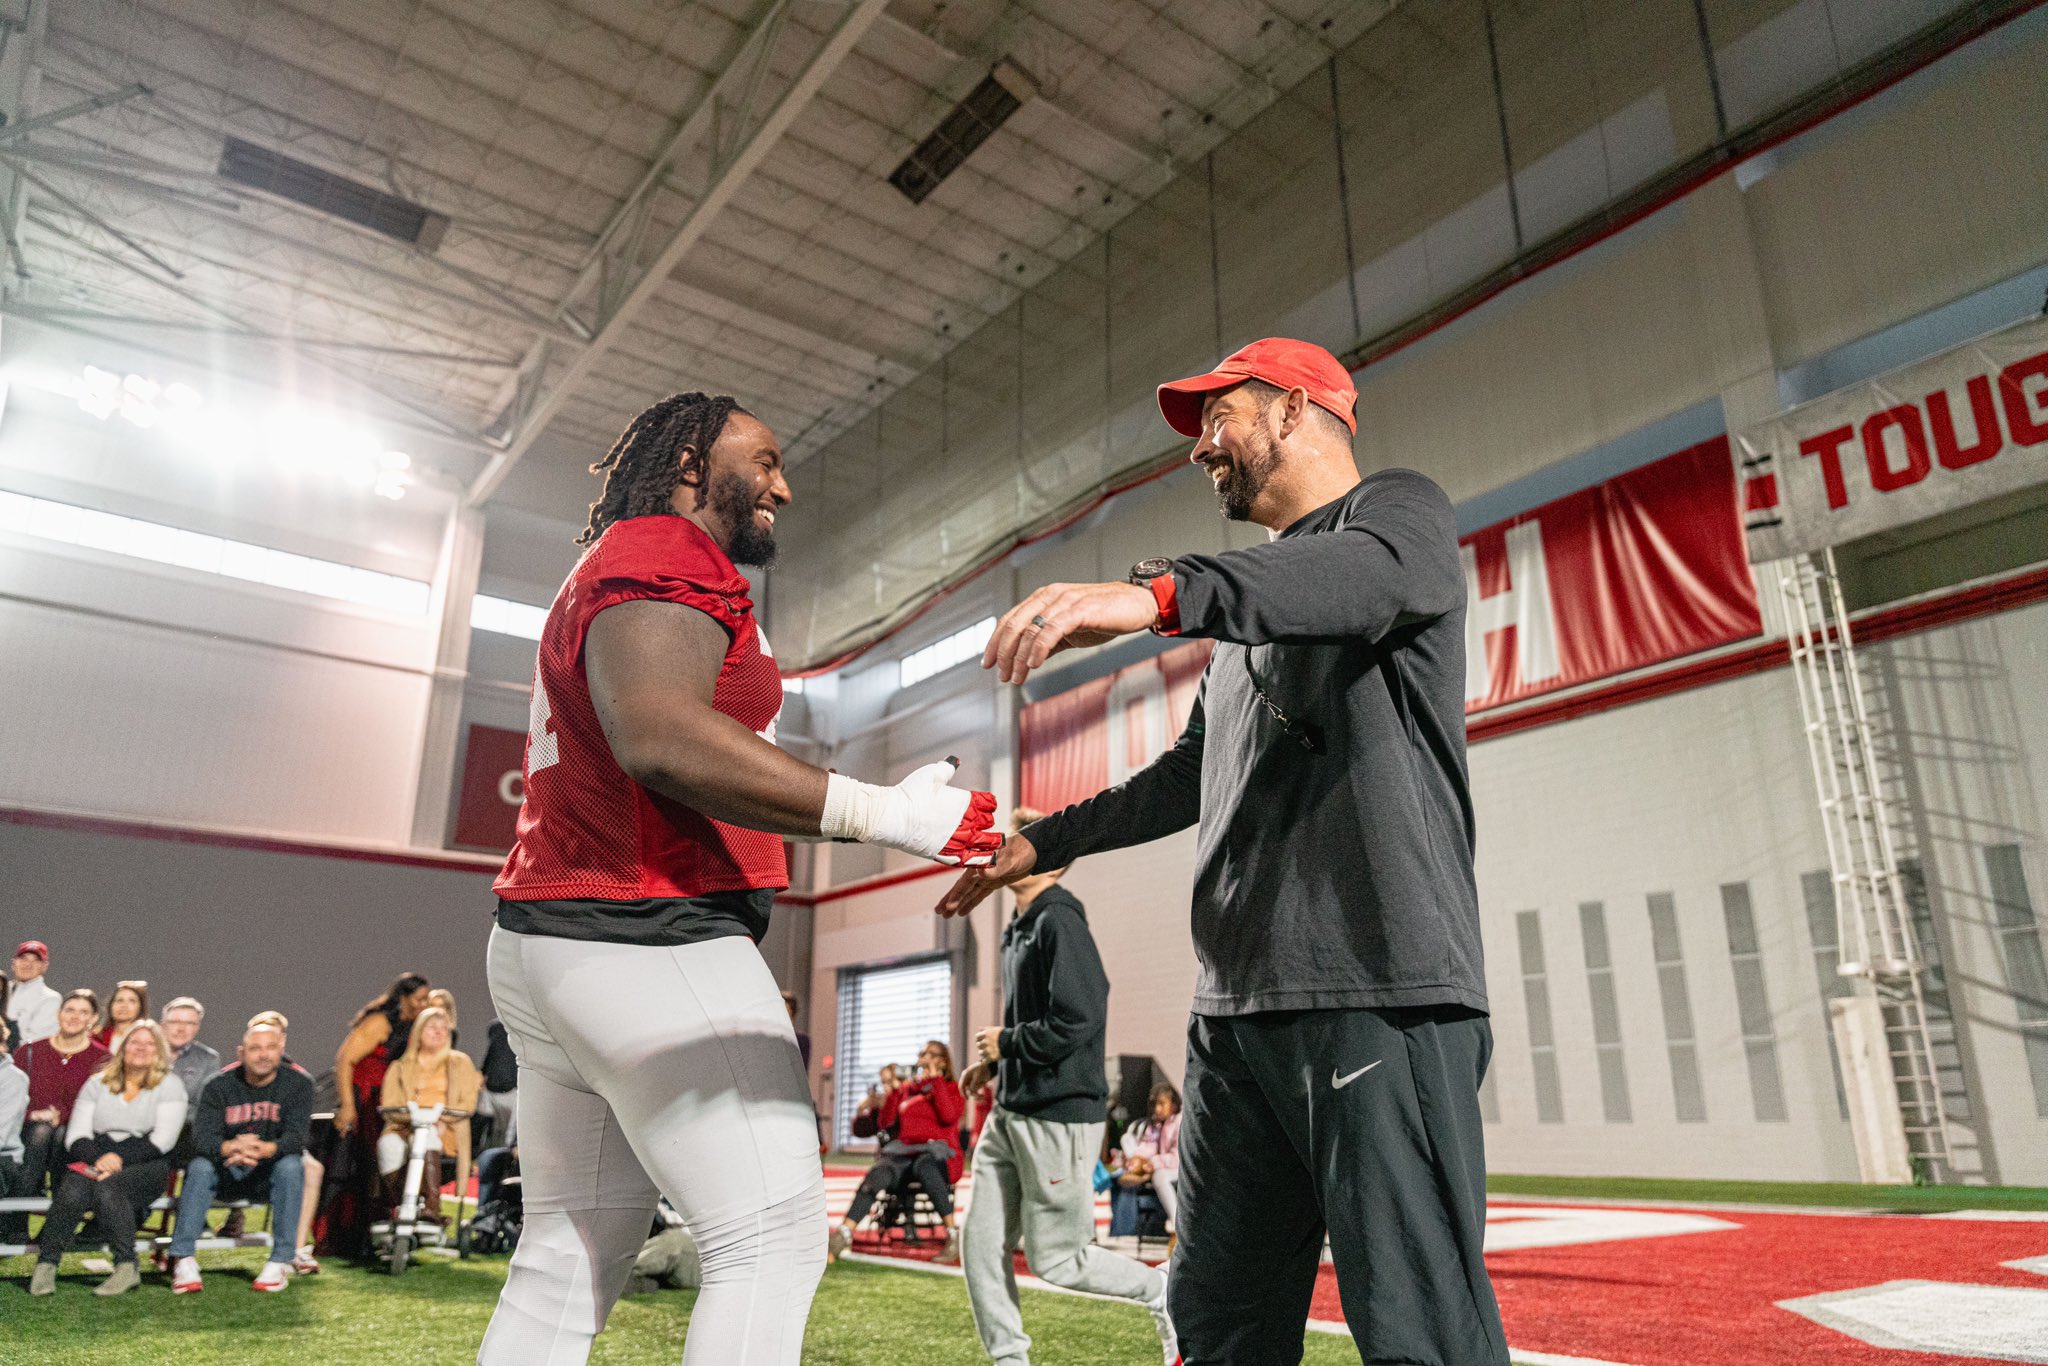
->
[[1167, 1006, 1507, 1366]]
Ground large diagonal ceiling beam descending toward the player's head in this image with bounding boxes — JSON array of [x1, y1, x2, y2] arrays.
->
[[469, 0, 889, 506]]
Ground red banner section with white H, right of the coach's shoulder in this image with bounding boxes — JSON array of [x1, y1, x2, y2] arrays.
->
[[1458, 436, 1763, 713]]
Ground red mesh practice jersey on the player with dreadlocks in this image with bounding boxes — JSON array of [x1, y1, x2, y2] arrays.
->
[[496, 516, 788, 901]]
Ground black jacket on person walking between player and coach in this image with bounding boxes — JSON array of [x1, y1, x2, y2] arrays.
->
[[995, 885, 1110, 1124]]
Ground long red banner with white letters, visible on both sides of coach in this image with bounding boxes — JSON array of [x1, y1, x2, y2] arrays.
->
[[1018, 436, 1763, 811]]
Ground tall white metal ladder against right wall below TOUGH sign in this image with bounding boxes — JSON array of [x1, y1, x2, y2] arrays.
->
[[1780, 551, 1952, 1180]]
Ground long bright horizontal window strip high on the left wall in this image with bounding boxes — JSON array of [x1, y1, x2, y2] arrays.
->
[[0, 492, 430, 616]]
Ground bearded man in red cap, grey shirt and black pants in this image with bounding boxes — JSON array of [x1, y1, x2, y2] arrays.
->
[[938, 338, 1507, 1366]]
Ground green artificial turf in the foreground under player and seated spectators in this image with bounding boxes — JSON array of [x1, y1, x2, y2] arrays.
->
[[0, 1251, 1358, 1366]]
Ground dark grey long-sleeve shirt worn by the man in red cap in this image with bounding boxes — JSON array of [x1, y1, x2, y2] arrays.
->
[[1024, 469, 1487, 1016]]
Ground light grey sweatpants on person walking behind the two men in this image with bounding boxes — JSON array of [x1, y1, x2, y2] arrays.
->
[[961, 1106, 1165, 1366]]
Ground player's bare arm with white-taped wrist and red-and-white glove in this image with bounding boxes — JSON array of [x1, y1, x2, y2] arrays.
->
[[584, 598, 1001, 864]]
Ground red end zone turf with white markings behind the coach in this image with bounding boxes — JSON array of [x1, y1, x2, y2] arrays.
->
[[827, 1169, 2048, 1366]]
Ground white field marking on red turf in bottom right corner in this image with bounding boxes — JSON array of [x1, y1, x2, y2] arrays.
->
[[1778, 1280, 2048, 1362]]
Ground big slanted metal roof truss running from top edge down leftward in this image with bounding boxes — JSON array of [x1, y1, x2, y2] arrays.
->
[[469, 0, 905, 506]]
